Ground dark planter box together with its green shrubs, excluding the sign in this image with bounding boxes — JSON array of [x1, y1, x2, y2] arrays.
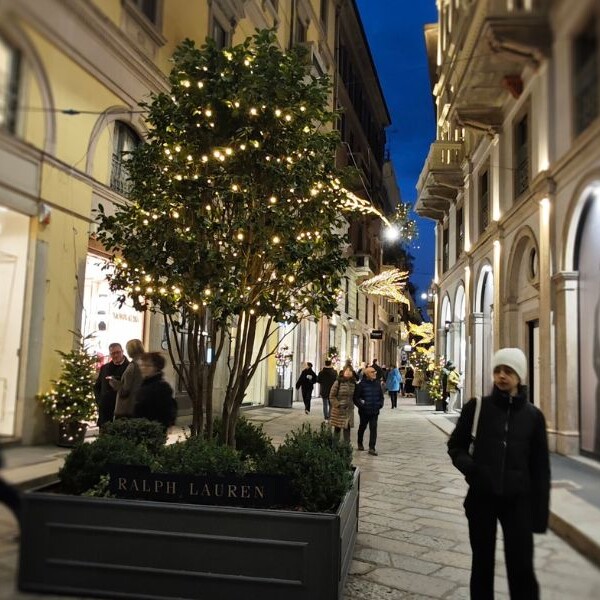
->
[[19, 425, 359, 600]]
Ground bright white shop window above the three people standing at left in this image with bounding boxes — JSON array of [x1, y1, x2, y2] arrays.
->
[[81, 254, 144, 365]]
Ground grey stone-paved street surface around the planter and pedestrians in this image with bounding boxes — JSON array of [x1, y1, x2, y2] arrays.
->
[[0, 398, 600, 600]]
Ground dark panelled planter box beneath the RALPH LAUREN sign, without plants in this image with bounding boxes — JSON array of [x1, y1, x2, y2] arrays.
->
[[18, 469, 360, 600]]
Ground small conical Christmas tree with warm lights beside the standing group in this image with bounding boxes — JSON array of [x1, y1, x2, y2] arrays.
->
[[38, 342, 96, 423]]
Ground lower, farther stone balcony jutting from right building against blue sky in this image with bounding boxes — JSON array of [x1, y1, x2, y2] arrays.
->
[[415, 140, 464, 221]]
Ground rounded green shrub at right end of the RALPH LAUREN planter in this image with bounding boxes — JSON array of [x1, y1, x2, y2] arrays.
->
[[265, 424, 352, 512]]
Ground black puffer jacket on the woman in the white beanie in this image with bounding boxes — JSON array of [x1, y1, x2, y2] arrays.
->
[[448, 386, 550, 532]]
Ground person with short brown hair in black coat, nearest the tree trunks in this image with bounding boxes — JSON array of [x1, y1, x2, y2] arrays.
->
[[135, 352, 177, 429]]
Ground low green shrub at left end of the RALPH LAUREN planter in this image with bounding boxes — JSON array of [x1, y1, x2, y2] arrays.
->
[[58, 435, 153, 494]]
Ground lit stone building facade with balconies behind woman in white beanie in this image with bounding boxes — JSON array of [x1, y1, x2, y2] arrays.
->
[[416, 0, 600, 459]]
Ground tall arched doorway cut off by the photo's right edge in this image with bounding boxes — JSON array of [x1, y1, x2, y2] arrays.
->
[[575, 188, 600, 457]]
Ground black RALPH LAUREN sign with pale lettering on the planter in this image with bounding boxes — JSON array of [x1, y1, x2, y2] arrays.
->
[[109, 465, 294, 508]]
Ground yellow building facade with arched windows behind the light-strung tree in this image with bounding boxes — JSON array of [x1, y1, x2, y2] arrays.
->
[[0, 0, 408, 444]]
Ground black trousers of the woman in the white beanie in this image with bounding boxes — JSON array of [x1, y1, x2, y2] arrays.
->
[[465, 490, 539, 600]]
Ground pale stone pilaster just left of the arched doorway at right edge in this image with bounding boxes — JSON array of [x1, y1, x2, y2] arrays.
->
[[552, 271, 580, 454]]
